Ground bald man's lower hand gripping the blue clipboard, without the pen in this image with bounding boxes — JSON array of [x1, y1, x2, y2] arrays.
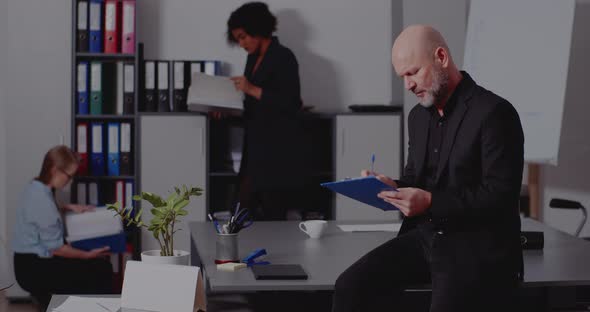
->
[[377, 187, 432, 217]]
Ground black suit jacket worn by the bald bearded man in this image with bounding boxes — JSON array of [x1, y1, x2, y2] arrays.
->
[[397, 72, 524, 276]]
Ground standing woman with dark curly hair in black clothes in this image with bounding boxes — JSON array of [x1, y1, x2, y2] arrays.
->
[[227, 2, 307, 220]]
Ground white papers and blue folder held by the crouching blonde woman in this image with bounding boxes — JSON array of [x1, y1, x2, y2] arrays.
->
[[65, 207, 125, 253]]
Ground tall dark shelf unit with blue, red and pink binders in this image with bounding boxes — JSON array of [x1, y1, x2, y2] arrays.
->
[[71, 0, 143, 266]]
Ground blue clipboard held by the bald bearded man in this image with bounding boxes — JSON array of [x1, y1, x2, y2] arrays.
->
[[321, 176, 398, 210]]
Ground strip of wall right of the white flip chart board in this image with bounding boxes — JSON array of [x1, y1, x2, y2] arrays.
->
[[542, 0, 590, 236]]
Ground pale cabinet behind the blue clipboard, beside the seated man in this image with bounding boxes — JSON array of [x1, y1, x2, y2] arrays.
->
[[334, 114, 402, 221]]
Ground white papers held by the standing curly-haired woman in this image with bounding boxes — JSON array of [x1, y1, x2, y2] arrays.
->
[[187, 73, 244, 112]]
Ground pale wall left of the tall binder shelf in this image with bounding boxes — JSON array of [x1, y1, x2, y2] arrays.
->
[[1, 0, 71, 298]]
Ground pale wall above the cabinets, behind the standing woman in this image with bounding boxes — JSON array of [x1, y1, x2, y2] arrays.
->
[[138, 0, 402, 111]]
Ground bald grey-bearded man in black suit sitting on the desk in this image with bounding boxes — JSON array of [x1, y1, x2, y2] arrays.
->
[[333, 25, 524, 312]]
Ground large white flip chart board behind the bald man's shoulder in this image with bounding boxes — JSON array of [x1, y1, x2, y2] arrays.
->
[[464, 0, 575, 165]]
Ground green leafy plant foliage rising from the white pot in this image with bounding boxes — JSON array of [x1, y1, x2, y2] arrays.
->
[[107, 185, 203, 256]]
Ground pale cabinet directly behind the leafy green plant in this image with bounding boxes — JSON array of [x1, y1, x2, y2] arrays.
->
[[140, 115, 207, 251]]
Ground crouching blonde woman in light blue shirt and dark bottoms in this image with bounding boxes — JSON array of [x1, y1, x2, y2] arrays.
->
[[12, 145, 113, 311]]
